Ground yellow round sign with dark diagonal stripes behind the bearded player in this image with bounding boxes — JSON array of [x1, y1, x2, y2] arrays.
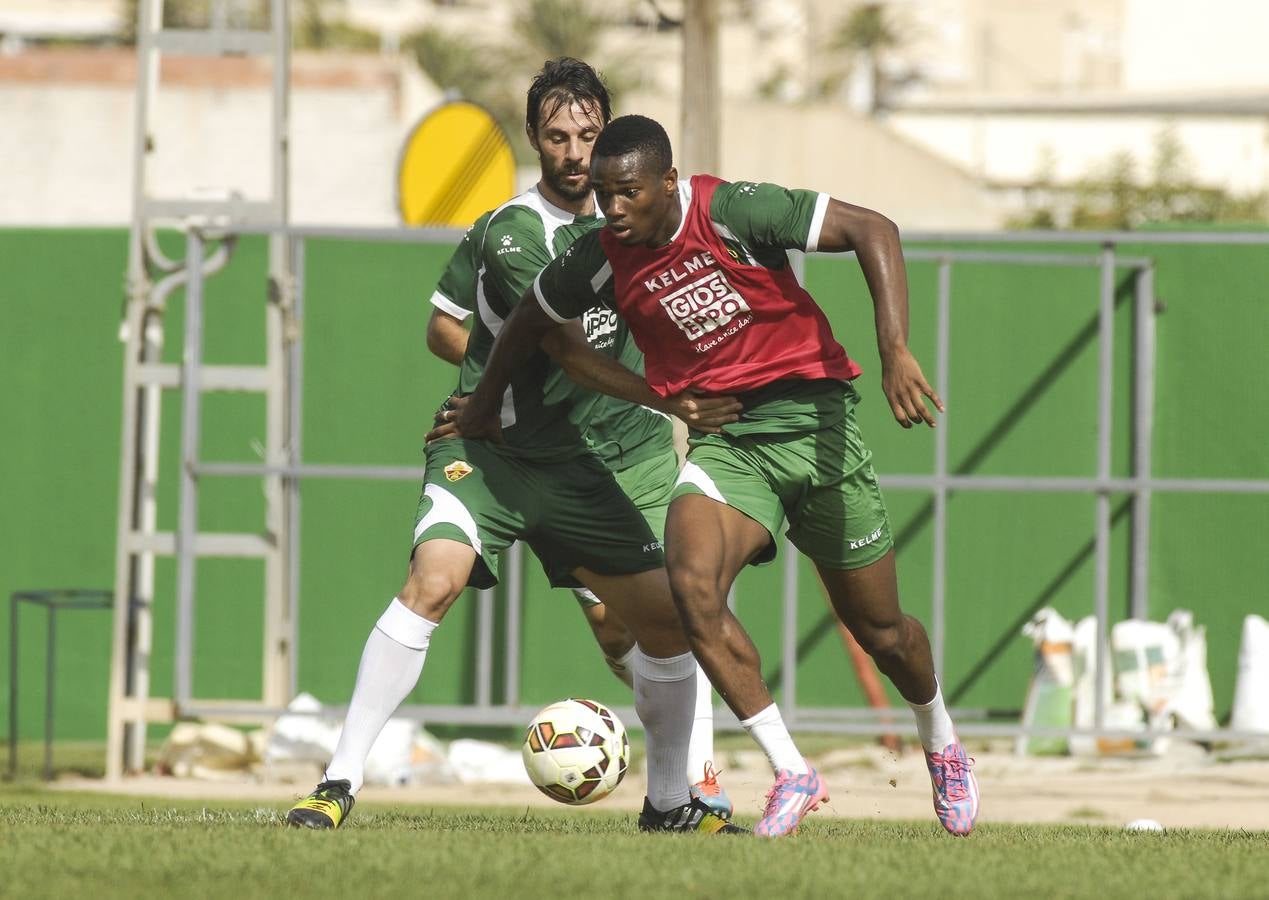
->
[[397, 100, 515, 226]]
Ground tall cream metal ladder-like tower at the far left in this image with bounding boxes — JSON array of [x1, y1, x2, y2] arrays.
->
[[105, 0, 291, 778]]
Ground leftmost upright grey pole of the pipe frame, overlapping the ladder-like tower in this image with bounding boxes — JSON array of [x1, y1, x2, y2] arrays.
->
[[173, 228, 203, 707]]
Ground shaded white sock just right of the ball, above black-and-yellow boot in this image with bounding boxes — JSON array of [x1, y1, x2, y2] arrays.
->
[[635, 647, 697, 812]]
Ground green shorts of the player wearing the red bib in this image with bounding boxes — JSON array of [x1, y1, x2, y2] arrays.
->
[[674, 404, 895, 569]]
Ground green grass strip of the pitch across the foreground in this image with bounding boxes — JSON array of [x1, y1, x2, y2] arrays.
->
[[0, 779, 1269, 900]]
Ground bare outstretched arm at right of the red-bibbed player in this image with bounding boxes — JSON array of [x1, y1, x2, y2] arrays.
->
[[807, 197, 944, 428]]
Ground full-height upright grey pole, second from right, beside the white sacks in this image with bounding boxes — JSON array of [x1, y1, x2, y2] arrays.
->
[[1094, 244, 1115, 729]]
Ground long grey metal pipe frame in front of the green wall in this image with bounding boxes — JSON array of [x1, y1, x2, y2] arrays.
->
[[106, 225, 1269, 756]]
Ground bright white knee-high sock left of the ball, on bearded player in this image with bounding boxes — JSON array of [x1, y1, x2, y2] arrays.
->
[[326, 598, 437, 793]]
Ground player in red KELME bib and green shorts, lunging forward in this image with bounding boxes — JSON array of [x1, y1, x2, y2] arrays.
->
[[461, 116, 978, 837]]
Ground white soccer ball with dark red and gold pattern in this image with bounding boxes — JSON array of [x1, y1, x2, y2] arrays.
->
[[520, 698, 631, 806]]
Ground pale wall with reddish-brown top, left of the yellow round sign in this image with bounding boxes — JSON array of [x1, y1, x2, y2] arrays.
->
[[0, 51, 440, 226]]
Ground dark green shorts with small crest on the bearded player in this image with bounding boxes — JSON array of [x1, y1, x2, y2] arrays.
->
[[414, 438, 665, 588]]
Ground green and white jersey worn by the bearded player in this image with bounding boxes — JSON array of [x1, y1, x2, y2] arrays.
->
[[431, 188, 673, 470]]
